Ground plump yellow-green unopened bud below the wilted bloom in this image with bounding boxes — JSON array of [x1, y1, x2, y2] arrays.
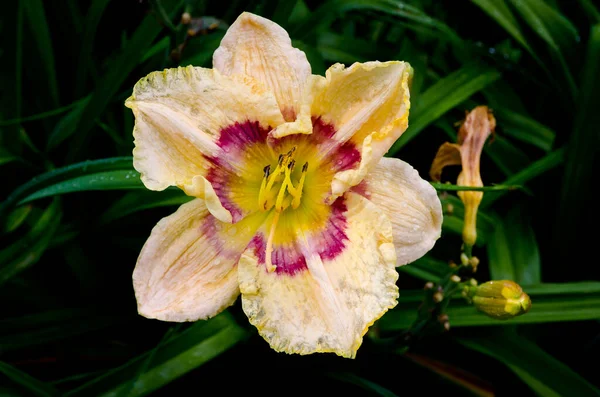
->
[[470, 280, 531, 320]]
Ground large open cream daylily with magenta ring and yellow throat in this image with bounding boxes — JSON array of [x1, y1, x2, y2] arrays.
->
[[126, 13, 442, 357]]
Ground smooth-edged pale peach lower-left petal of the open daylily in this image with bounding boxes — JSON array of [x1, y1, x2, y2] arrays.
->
[[133, 199, 260, 322]]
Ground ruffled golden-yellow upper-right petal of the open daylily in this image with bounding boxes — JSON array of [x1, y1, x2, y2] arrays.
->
[[312, 61, 412, 198]]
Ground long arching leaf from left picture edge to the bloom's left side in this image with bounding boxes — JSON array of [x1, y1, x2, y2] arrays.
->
[[0, 157, 133, 219]]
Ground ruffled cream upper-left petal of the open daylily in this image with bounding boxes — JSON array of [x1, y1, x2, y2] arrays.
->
[[125, 66, 284, 190]]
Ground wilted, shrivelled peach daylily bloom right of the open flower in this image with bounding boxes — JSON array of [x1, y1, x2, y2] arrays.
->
[[429, 106, 496, 246]]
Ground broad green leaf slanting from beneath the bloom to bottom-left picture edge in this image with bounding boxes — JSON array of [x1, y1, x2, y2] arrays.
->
[[64, 312, 247, 397]]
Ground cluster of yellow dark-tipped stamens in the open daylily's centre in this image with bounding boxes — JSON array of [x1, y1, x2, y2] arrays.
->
[[258, 146, 308, 213]]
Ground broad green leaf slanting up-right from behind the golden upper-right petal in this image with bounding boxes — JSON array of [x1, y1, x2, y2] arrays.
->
[[388, 64, 500, 152]]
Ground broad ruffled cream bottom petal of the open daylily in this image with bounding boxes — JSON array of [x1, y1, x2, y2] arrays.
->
[[239, 193, 398, 358]]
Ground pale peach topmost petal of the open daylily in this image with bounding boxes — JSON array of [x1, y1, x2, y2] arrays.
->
[[213, 12, 311, 121]]
